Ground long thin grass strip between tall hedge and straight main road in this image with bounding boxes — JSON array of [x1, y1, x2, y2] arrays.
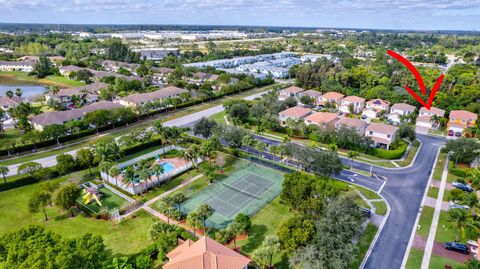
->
[[0, 84, 277, 165]]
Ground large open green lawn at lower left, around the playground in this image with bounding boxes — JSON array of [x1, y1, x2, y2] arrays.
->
[[0, 171, 155, 255]]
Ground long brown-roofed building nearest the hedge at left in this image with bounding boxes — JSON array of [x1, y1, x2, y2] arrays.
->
[[29, 101, 123, 131]]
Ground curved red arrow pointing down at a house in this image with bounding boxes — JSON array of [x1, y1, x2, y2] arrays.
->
[[387, 50, 444, 110]]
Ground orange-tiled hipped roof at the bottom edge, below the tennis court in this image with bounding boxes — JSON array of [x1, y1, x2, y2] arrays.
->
[[162, 236, 251, 269]]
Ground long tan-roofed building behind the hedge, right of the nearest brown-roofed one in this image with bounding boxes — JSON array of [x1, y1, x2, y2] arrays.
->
[[118, 86, 189, 107]]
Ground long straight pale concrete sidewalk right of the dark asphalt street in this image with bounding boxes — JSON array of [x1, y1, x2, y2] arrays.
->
[[421, 157, 449, 269]]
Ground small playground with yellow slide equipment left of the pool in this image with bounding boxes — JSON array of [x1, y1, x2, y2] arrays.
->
[[77, 182, 129, 215]]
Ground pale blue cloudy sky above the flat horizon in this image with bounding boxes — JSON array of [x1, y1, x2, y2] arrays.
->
[[0, 0, 480, 30]]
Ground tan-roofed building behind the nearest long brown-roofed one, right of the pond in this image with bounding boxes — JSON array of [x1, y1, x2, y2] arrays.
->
[[45, 82, 108, 108]]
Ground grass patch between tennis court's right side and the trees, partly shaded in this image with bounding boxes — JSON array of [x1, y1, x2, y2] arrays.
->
[[237, 197, 294, 269]]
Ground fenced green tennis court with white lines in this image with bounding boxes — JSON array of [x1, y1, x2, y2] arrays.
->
[[182, 160, 283, 228]]
